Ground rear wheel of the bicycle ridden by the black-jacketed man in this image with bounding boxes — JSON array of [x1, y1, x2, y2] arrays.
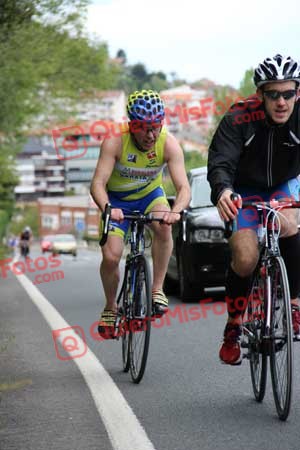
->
[[247, 266, 268, 402]]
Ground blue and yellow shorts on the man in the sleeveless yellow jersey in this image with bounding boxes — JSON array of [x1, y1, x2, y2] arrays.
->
[[99, 186, 169, 239]]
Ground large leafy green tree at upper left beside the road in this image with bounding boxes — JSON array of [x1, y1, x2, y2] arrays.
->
[[0, 0, 116, 250]]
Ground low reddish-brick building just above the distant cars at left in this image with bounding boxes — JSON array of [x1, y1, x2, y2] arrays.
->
[[38, 195, 100, 238]]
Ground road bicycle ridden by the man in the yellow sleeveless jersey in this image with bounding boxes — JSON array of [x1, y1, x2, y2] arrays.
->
[[100, 204, 183, 383]]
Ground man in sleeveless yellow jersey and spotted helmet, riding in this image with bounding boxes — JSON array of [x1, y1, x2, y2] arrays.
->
[[91, 90, 190, 337]]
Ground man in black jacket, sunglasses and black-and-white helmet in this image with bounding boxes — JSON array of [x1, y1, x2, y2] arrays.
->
[[208, 55, 300, 365]]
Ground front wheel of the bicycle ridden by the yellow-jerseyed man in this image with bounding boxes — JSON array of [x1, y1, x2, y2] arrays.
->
[[129, 255, 152, 383]]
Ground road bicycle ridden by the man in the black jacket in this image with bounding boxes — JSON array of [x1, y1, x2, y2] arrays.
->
[[227, 197, 300, 420]]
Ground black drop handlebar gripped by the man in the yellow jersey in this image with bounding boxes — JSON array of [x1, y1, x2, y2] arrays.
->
[[99, 203, 186, 247]]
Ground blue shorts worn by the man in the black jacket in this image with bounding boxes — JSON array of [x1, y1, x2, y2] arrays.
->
[[235, 178, 300, 230]]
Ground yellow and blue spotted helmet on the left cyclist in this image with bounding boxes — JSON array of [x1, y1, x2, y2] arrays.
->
[[127, 89, 165, 122]]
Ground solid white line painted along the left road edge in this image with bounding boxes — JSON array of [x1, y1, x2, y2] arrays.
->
[[16, 275, 155, 450]]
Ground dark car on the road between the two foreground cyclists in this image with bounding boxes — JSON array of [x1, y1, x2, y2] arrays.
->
[[164, 167, 230, 302]]
